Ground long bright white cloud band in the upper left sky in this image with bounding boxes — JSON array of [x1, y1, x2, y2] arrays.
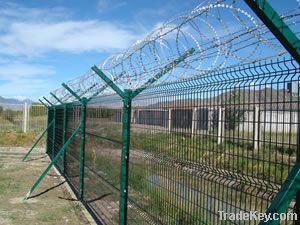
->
[[0, 20, 140, 56]]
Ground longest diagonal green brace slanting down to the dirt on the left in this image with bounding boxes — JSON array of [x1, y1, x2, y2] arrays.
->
[[24, 126, 81, 200]]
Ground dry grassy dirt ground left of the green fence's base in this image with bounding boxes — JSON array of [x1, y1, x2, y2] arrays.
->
[[0, 147, 95, 225]]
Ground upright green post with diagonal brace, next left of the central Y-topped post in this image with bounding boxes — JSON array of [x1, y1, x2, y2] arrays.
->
[[78, 97, 87, 200]]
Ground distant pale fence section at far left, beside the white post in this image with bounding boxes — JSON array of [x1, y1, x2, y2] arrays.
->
[[0, 104, 24, 132]]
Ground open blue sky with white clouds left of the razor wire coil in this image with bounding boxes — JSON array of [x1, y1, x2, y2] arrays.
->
[[0, 0, 293, 100]]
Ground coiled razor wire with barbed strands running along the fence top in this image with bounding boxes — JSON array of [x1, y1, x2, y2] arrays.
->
[[45, 0, 299, 104]]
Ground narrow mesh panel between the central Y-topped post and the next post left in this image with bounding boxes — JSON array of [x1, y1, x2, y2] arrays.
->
[[84, 95, 123, 224]]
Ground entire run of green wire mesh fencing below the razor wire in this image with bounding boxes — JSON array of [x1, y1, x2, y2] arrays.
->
[[44, 56, 300, 224]]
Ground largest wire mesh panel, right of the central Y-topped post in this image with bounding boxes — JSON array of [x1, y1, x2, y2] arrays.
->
[[128, 59, 299, 224]]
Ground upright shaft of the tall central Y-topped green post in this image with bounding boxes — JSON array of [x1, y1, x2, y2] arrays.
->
[[119, 90, 132, 225]]
